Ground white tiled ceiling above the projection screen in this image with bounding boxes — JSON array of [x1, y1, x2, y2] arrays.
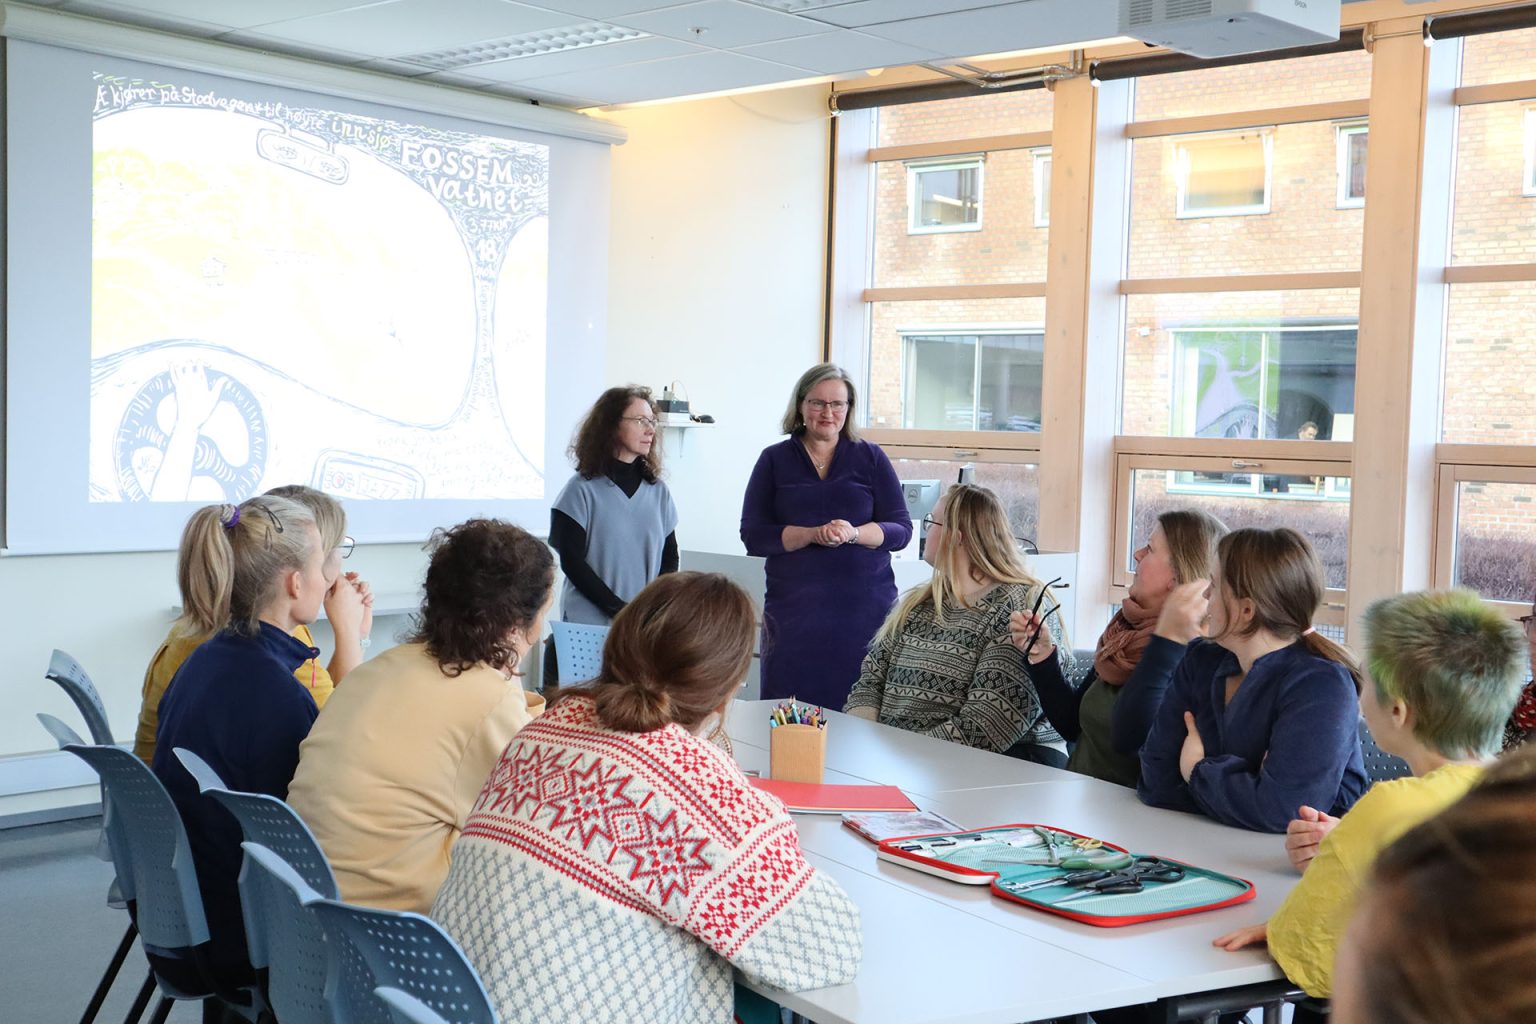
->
[[21, 0, 1120, 107]]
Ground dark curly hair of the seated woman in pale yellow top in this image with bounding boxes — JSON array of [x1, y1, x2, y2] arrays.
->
[[406, 519, 554, 676]]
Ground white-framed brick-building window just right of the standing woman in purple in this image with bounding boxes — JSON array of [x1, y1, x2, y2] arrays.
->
[[900, 327, 1044, 433]]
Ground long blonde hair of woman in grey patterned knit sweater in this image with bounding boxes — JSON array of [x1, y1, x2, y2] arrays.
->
[[874, 484, 1058, 643]]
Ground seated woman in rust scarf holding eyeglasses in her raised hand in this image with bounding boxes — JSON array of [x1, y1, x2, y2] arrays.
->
[[1009, 508, 1227, 786]]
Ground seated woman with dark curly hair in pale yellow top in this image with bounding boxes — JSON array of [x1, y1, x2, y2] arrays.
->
[[289, 519, 554, 913]]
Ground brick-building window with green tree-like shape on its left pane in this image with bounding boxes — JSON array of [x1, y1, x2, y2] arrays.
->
[[1169, 325, 1355, 441]]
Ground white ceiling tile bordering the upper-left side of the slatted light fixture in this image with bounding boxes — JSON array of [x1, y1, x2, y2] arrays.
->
[[242, 0, 571, 57]]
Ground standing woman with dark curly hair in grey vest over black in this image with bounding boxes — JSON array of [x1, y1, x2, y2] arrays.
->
[[544, 385, 677, 688]]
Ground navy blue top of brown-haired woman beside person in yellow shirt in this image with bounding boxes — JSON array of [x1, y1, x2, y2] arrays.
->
[[1137, 640, 1369, 832]]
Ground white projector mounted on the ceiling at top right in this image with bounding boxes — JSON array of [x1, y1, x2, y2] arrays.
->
[[1120, 0, 1339, 57]]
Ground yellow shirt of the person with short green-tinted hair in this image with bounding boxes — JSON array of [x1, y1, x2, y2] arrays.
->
[[1269, 765, 1482, 998]]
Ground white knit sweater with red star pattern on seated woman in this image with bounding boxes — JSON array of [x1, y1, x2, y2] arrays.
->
[[432, 697, 863, 1024]]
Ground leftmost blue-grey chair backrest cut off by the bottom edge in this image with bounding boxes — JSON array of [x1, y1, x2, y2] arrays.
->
[[240, 841, 334, 1024]]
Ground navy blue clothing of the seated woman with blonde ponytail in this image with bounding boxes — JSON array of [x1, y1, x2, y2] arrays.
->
[[151, 622, 319, 969]]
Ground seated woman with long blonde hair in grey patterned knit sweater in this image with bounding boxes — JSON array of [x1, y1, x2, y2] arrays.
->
[[845, 484, 1072, 766]]
